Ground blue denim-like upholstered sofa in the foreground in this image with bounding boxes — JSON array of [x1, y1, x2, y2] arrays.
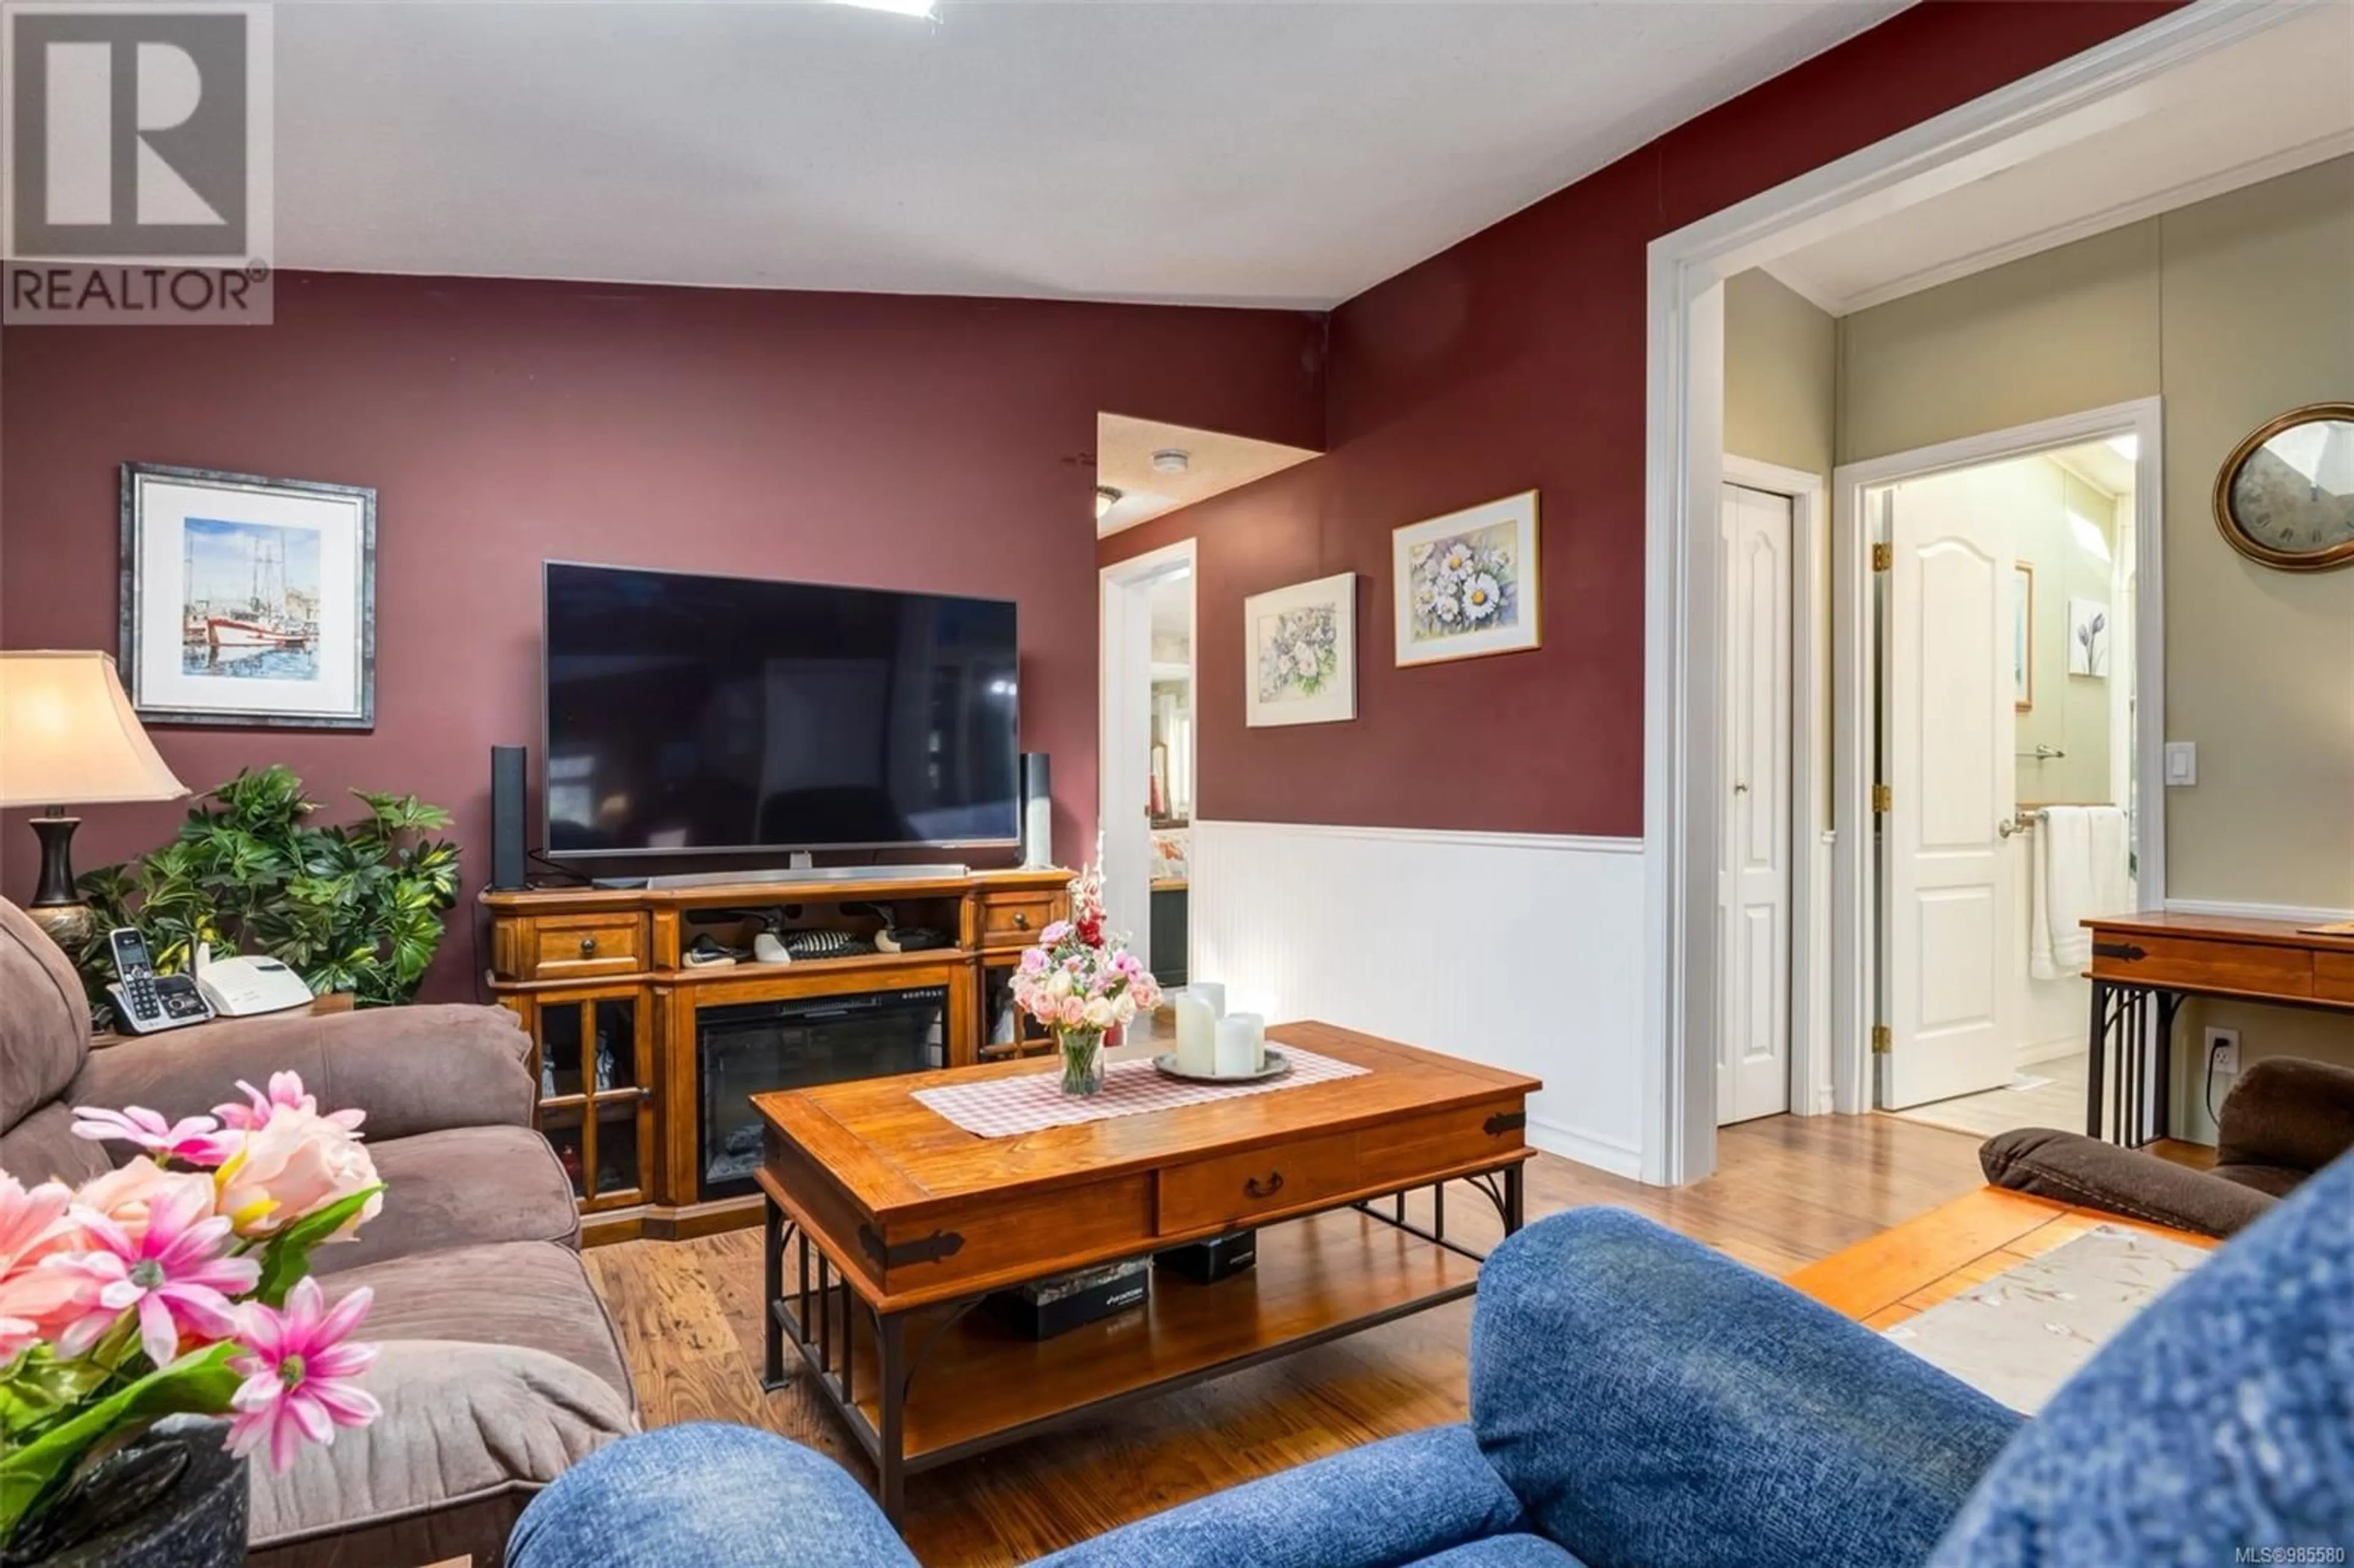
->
[[508, 1156, 2354, 1568]]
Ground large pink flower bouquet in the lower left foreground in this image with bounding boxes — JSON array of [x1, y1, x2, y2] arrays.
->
[[0, 1073, 384, 1549]]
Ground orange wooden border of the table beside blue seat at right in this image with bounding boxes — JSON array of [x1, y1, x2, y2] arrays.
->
[[1787, 1187, 2222, 1328]]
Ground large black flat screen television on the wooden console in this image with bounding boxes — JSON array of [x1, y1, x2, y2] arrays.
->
[[541, 560, 1022, 857]]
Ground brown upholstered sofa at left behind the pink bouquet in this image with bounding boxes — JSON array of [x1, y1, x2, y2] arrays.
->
[[0, 902, 636, 1568]]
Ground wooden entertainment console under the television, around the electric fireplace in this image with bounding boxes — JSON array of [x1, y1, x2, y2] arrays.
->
[[482, 869, 1071, 1246]]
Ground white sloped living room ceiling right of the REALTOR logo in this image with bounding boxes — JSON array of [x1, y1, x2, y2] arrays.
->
[[275, 0, 1902, 308]]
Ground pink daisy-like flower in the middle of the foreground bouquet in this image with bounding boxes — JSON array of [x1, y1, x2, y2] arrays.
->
[[42, 1184, 261, 1366]]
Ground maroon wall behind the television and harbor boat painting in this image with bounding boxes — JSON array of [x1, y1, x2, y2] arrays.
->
[[0, 273, 1323, 996]]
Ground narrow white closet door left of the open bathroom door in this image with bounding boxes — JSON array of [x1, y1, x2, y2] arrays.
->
[[1716, 485, 1794, 1125]]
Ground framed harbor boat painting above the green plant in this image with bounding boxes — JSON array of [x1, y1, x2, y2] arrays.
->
[[120, 464, 376, 730]]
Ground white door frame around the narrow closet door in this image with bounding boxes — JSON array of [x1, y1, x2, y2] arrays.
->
[[1716, 452, 1834, 1116]]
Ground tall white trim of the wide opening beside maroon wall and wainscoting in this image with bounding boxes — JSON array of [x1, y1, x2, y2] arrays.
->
[[1640, 0, 2303, 1182]]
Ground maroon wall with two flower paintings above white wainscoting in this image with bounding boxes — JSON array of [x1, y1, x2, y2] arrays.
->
[[1102, 0, 2173, 835]]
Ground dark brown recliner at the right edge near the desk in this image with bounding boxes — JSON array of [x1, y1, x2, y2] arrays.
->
[[1978, 1057, 2354, 1236]]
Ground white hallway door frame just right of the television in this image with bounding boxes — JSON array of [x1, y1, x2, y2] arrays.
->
[[1087, 539, 1200, 951]]
